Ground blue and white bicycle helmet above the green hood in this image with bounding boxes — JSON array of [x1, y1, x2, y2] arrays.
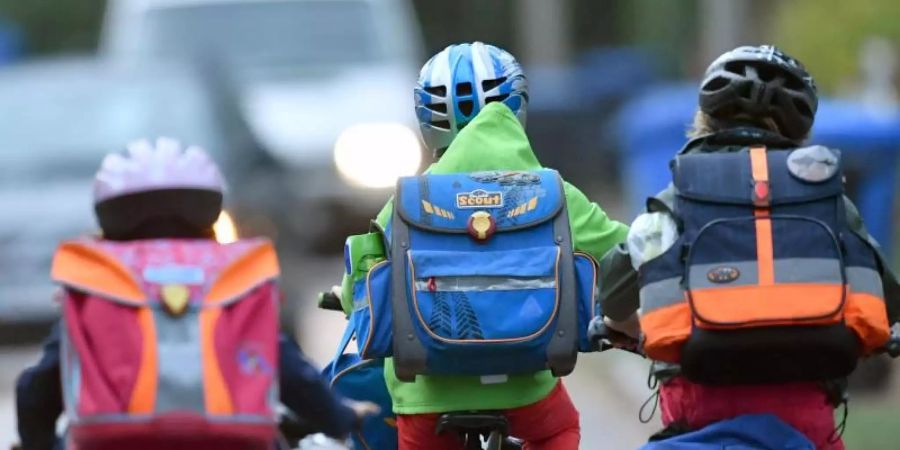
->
[[415, 42, 528, 156]]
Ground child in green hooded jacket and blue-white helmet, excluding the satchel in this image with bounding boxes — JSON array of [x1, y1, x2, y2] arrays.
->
[[343, 42, 628, 450]]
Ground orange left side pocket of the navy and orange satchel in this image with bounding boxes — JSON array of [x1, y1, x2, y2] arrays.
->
[[641, 302, 691, 363]]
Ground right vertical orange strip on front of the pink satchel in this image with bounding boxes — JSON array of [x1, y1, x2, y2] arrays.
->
[[200, 308, 234, 414]]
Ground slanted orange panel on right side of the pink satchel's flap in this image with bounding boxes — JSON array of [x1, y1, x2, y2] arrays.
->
[[205, 242, 279, 303]]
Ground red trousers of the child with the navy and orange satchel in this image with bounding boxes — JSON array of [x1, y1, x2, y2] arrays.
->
[[660, 378, 844, 450]]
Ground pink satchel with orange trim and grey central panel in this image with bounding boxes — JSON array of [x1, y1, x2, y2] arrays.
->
[[52, 240, 279, 450]]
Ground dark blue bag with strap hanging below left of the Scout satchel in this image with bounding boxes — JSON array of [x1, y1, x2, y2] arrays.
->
[[322, 315, 398, 450]]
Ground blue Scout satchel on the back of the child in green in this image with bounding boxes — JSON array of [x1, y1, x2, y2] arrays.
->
[[366, 170, 596, 381]]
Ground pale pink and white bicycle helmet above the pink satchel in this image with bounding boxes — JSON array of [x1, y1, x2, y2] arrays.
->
[[94, 138, 225, 239]]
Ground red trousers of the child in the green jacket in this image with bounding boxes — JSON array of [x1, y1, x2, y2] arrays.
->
[[397, 381, 581, 450]]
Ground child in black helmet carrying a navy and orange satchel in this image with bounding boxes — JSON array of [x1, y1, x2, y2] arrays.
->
[[600, 46, 900, 450]]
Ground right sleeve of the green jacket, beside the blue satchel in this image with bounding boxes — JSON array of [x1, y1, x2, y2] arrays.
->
[[565, 183, 628, 260]]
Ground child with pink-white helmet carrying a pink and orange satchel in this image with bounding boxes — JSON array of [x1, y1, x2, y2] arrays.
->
[[16, 138, 374, 450]]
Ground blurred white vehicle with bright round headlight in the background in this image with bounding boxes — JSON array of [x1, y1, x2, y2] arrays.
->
[[101, 0, 423, 244]]
